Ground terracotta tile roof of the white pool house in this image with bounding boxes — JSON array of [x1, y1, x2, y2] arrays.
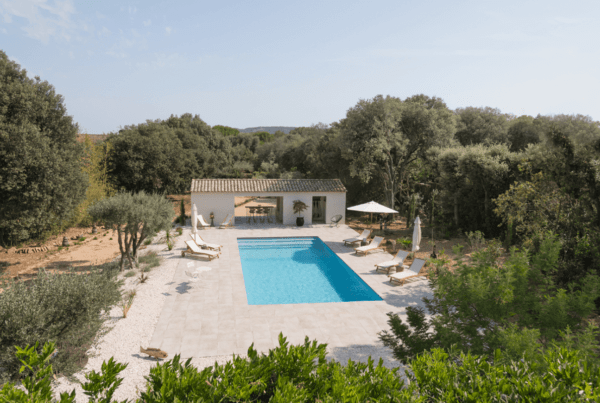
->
[[191, 179, 346, 193]]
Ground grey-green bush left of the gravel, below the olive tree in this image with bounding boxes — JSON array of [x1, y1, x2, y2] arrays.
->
[[0, 264, 120, 382]]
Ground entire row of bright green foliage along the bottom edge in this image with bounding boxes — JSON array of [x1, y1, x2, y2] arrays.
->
[[5, 335, 600, 403]]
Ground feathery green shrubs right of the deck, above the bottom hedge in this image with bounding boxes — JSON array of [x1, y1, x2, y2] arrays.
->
[[380, 234, 600, 362]]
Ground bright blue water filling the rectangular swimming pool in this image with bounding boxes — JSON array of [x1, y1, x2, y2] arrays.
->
[[238, 237, 381, 305]]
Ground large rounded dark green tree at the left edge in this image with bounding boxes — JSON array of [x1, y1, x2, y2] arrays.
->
[[0, 51, 87, 245]]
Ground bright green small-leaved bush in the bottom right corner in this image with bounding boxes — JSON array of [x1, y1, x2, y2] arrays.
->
[[409, 347, 600, 402]]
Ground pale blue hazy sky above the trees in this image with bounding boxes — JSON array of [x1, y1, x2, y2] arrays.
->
[[0, 0, 600, 133]]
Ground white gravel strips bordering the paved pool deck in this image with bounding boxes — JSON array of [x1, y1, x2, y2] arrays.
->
[[54, 230, 408, 403]]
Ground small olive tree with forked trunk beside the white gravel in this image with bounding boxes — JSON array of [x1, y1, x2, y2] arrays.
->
[[88, 191, 175, 271]]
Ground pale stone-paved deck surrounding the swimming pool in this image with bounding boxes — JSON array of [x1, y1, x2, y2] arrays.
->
[[150, 225, 432, 359]]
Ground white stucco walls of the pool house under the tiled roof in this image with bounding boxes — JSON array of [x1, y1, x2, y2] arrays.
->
[[192, 192, 346, 225]]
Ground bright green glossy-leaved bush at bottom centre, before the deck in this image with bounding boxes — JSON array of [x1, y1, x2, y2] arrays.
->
[[140, 334, 412, 403]]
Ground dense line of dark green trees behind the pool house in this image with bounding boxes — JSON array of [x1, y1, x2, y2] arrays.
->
[[0, 53, 600, 288]]
